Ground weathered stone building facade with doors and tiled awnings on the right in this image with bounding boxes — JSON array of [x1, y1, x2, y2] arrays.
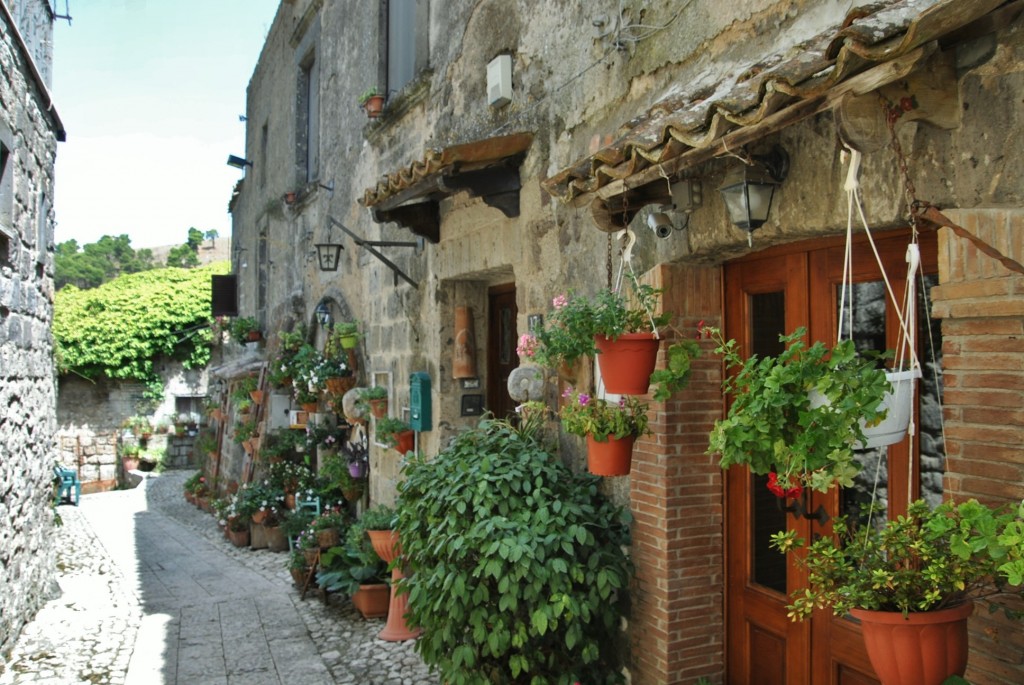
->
[[230, 0, 1024, 684]]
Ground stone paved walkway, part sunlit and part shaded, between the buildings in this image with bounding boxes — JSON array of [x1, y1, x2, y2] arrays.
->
[[0, 471, 437, 685]]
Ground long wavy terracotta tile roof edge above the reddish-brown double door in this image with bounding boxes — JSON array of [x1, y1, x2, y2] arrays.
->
[[542, 0, 1001, 205]]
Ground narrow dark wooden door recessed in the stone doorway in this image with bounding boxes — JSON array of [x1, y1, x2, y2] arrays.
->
[[487, 284, 519, 418]]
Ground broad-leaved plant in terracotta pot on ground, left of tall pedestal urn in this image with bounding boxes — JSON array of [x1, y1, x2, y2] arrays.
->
[[316, 521, 390, 618]]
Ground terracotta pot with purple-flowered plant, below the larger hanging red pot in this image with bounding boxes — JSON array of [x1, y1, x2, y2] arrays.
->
[[558, 388, 650, 476]]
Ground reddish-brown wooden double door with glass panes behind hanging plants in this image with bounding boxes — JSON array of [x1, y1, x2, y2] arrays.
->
[[725, 231, 941, 685]]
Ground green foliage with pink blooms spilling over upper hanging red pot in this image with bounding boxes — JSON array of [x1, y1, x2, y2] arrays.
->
[[518, 279, 669, 367]]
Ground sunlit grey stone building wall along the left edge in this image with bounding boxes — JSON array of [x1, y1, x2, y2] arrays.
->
[[0, 0, 65, 655]]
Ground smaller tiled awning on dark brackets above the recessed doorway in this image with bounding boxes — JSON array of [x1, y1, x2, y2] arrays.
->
[[359, 133, 534, 243]]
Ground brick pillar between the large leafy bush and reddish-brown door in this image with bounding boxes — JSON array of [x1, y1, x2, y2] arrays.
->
[[630, 265, 724, 685]]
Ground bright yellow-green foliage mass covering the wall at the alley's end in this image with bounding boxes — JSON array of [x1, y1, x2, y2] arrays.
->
[[53, 261, 230, 395]]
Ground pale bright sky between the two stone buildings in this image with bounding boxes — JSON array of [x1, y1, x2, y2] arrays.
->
[[51, 0, 279, 249]]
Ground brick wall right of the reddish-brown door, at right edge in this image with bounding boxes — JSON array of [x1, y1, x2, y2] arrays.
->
[[932, 209, 1024, 685]]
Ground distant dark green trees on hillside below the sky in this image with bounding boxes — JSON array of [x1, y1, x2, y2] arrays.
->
[[53, 234, 154, 290]]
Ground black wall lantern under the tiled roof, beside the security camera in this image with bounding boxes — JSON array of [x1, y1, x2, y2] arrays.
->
[[719, 145, 790, 232]]
